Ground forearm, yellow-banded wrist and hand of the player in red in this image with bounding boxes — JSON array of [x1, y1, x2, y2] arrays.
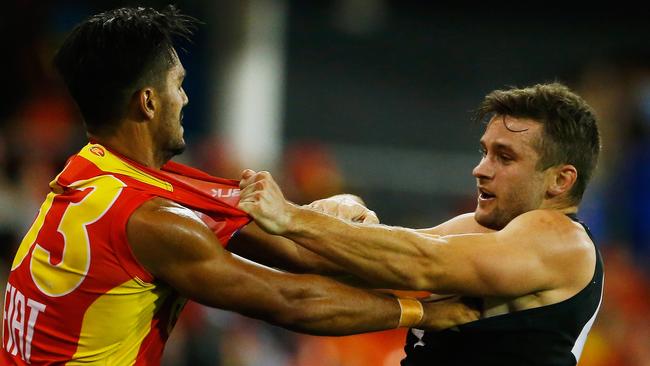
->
[[268, 276, 480, 336]]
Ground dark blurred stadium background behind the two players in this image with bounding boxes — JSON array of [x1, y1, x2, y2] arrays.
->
[[0, 0, 650, 366]]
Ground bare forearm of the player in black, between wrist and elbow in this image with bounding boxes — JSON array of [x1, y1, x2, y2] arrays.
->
[[282, 207, 442, 290]]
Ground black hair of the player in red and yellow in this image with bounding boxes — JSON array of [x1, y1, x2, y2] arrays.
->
[[54, 5, 198, 133]]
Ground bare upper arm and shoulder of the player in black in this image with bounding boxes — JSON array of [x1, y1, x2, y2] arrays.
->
[[428, 213, 589, 297]]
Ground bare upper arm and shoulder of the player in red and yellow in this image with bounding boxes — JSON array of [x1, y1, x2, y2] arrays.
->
[[127, 200, 296, 316]]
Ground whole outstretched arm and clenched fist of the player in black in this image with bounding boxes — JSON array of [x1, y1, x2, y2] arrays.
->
[[239, 171, 594, 297]]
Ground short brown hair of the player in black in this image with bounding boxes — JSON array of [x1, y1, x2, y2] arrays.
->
[[477, 82, 600, 204]]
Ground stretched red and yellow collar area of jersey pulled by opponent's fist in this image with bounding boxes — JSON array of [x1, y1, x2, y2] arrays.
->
[[50, 141, 251, 247]]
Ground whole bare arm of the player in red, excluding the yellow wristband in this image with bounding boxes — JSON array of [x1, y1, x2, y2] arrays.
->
[[127, 198, 478, 335]]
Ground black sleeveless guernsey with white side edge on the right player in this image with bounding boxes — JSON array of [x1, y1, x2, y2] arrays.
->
[[401, 215, 603, 366]]
